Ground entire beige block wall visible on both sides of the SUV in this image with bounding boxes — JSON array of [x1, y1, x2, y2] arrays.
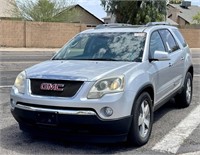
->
[[0, 20, 200, 48]]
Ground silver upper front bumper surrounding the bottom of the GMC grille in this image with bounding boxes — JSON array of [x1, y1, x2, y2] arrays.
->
[[10, 85, 135, 120]]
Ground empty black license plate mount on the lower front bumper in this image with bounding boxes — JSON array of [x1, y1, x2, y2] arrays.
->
[[36, 112, 58, 126]]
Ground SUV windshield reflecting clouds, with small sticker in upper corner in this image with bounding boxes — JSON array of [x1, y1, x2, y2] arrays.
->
[[53, 32, 146, 62]]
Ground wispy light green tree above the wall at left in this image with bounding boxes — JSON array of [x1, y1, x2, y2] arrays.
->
[[10, 0, 74, 22]]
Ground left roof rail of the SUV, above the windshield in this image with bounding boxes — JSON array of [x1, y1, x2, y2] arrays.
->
[[95, 23, 142, 29]]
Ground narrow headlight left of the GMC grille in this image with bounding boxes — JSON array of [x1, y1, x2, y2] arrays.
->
[[14, 71, 26, 94]]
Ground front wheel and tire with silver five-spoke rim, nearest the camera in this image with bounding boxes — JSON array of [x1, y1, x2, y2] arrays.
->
[[128, 92, 153, 146]]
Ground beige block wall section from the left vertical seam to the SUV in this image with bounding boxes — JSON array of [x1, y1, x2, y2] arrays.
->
[[26, 22, 86, 47]]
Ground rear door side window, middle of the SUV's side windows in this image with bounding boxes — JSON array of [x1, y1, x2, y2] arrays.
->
[[159, 29, 180, 53]]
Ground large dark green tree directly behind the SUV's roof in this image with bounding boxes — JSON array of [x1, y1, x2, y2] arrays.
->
[[101, 0, 166, 24]]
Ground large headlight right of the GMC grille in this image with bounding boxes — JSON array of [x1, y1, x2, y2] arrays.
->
[[88, 76, 124, 99]]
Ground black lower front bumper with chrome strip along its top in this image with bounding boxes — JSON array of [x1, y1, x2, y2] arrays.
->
[[11, 103, 132, 142]]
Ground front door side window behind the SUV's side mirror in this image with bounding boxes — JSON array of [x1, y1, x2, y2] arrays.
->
[[149, 31, 165, 58]]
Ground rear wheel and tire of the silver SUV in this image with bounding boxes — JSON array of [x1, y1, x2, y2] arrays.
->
[[175, 72, 193, 108]]
